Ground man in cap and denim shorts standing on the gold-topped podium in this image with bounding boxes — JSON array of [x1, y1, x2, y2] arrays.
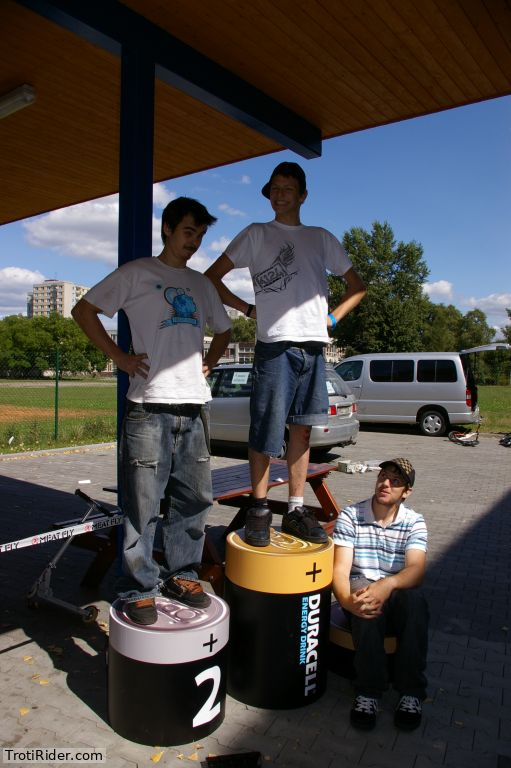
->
[[206, 162, 365, 547]]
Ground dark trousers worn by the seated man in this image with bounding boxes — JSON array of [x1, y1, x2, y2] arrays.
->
[[347, 588, 429, 700]]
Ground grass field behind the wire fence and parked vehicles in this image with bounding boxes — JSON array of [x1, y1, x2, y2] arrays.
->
[[0, 381, 511, 454]]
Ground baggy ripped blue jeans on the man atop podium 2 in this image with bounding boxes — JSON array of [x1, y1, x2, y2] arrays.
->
[[118, 401, 213, 601]]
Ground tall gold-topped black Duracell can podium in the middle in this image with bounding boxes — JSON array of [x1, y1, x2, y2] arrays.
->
[[224, 529, 334, 709]]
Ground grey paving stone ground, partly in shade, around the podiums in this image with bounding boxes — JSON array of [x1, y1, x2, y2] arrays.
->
[[0, 428, 511, 768]]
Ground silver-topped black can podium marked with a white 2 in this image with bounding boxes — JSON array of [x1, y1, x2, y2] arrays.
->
[[108, 595, 229, 746]]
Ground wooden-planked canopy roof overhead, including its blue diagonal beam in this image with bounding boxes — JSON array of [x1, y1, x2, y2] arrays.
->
[[0, 0, 511, 223]]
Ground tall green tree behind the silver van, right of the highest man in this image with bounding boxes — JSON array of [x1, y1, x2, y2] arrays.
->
[[329, 221, 430, 354]]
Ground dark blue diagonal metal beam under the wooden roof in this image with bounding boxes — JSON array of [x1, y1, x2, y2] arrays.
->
[[17, 0, 321, 159]]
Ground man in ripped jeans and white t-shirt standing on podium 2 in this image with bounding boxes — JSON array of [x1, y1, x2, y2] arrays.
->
[[72, 197, 230, 624]]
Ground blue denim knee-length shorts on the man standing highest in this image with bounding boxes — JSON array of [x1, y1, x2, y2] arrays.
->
[[248, 341, 328, 456]]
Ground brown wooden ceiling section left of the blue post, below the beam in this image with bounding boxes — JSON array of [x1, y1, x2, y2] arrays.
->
[[0, 3, 120, 222]]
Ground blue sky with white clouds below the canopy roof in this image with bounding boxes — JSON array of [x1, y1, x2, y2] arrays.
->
[[0, 97, 511, 326]]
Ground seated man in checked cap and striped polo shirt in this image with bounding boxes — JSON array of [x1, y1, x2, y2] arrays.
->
[[333, 459, 429, 731]]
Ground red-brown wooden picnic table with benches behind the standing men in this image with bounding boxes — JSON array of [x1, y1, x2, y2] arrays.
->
[[54, 459, 339, 593]]
